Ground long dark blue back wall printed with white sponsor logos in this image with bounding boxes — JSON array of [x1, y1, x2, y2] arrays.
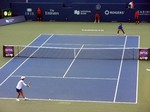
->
[[11, 2, 150, 22]]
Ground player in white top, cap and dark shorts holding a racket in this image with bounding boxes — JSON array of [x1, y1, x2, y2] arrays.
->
[[16, 76, 30, 101]]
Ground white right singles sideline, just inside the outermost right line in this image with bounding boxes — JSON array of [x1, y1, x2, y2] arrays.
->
[[113, 36, 128, 102]]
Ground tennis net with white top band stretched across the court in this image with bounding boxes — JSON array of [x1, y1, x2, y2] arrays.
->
[[4, 45, 139, 60]]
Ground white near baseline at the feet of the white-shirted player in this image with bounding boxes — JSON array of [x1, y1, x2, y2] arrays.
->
[[0, 97, 137, 105]]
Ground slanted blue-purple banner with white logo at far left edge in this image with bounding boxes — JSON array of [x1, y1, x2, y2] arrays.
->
[[0, 16, 26, 26]]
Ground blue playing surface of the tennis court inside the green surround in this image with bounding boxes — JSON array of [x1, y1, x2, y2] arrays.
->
[[0, 34, 139, 104]]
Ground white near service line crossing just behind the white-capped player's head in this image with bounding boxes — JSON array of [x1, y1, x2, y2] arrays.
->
[[11, 75, 117, 81]]
